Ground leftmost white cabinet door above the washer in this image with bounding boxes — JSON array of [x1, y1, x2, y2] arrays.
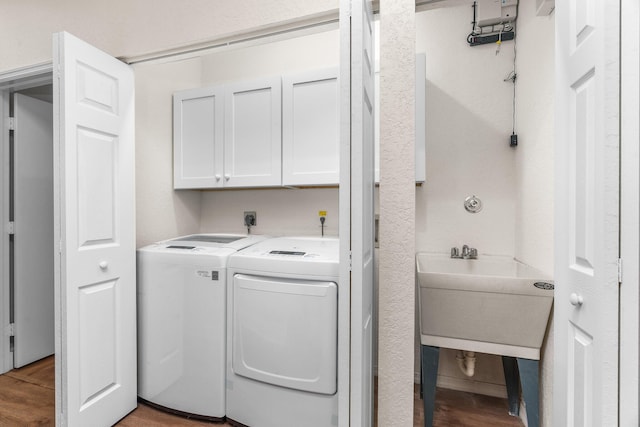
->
[[173, 87, 224, 189]]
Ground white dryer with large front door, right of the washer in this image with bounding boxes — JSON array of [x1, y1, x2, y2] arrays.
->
[[227, 237, 348, 427]]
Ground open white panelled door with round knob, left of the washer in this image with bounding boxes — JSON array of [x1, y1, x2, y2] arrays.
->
[[53, 33, 136, 426]]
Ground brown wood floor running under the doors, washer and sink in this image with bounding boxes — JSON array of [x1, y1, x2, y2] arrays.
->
[[0, 356, 523, 427]]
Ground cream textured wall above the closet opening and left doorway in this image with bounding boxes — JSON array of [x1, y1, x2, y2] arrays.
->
[[0, 0, 338, 71]]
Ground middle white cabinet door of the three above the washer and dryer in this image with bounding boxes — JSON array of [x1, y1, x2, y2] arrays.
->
[[224, 77, 282, 187]]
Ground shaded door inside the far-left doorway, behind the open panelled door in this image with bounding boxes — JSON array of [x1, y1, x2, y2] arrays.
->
[[13, 93, 54, 368]]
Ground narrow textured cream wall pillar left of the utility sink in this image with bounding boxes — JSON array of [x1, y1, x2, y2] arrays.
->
[[378, 0, 416, 426]]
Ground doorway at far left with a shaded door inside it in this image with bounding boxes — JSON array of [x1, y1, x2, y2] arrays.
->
[[0, 81, 54, 373]]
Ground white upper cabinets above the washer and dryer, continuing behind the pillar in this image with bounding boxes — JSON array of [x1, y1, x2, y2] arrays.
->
[[173, 54, 426, 189]]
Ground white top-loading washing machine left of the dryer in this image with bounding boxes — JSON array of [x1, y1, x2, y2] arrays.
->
[[137, 234, 266, 420]]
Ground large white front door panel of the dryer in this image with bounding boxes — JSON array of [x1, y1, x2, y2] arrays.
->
[[232, 274, 338, 394]]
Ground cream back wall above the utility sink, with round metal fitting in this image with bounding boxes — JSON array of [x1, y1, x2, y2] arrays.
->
[[416, 5, 516, 255]]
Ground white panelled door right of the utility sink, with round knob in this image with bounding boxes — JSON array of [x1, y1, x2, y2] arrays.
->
[[553, 0, 620, 427]]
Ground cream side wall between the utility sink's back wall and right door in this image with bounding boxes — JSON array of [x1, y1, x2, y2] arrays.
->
[[515, 1, 555, 426]]
